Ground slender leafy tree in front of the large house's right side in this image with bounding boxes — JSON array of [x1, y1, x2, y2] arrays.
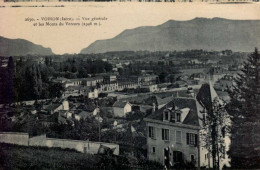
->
[[201, 97, 230, 169]]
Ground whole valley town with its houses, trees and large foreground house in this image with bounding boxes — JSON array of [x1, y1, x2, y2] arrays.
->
[[0, 50, 258, 169]]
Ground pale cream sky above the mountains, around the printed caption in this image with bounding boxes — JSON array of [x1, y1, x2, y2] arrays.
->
[[0, 2, 260, 54]]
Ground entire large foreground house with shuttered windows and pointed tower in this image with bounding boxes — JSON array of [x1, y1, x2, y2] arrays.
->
[[144, 83, 230, 168]]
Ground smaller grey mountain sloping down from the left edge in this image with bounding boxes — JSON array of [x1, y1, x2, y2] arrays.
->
[[0, 36, 53, 56]]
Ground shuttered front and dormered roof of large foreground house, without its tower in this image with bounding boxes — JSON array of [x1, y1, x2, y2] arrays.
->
[[144, 98, 200, 168]]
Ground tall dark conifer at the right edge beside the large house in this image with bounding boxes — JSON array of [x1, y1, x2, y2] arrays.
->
[[227, 49, 260, 169]]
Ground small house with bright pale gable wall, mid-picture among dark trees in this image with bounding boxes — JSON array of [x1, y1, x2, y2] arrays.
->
[[113, 101, 132, 117]]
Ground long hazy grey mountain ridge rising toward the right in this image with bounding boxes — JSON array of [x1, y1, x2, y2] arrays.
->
[[81, 18, 260, 54]]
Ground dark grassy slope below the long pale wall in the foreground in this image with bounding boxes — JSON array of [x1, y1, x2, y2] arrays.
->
[[0, 143, 162, 170]]
